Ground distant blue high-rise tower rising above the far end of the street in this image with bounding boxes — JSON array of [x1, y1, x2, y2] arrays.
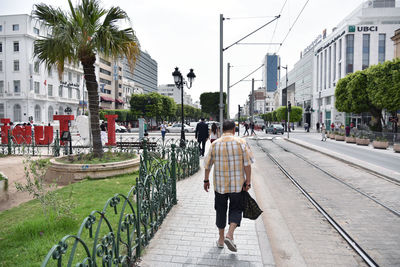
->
[[262, 54, 280, 92]]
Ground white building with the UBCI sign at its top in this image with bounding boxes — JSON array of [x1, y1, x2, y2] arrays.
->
[[314, 0, 400, 126]]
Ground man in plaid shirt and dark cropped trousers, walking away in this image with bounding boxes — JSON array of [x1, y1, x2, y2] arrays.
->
[[204, 120, 254, 252]]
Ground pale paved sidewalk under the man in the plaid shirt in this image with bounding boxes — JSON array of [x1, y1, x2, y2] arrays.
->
[[139, 160, 275, 267]]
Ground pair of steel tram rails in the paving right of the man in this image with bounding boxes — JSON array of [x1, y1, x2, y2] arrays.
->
[[255, 139, 400, 266]]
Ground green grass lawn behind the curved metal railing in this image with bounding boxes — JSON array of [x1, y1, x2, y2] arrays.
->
[[0, 172, 138, 267]]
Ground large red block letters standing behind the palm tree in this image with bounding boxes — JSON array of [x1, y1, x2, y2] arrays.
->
[[0, 115, 118, 146]]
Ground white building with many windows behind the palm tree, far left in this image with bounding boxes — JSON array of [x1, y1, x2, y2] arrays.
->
[[0, 15, 87, 123]]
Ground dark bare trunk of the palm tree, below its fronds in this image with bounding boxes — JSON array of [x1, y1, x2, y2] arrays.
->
[[82, 61, 103, 158]]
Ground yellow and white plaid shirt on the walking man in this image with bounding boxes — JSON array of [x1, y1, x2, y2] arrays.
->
[[204, 133, 254, 194]]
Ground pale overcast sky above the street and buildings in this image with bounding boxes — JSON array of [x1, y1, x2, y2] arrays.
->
[[0, 0, 363, 116]]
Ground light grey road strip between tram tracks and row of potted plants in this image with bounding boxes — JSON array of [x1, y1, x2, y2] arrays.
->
[[285, 132, 400, 172]]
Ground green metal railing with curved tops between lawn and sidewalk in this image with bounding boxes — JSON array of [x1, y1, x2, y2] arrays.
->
[[41, 141, 199, 267]]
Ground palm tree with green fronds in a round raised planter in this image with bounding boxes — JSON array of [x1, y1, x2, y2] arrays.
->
[[33, 0, 140, 157]]
